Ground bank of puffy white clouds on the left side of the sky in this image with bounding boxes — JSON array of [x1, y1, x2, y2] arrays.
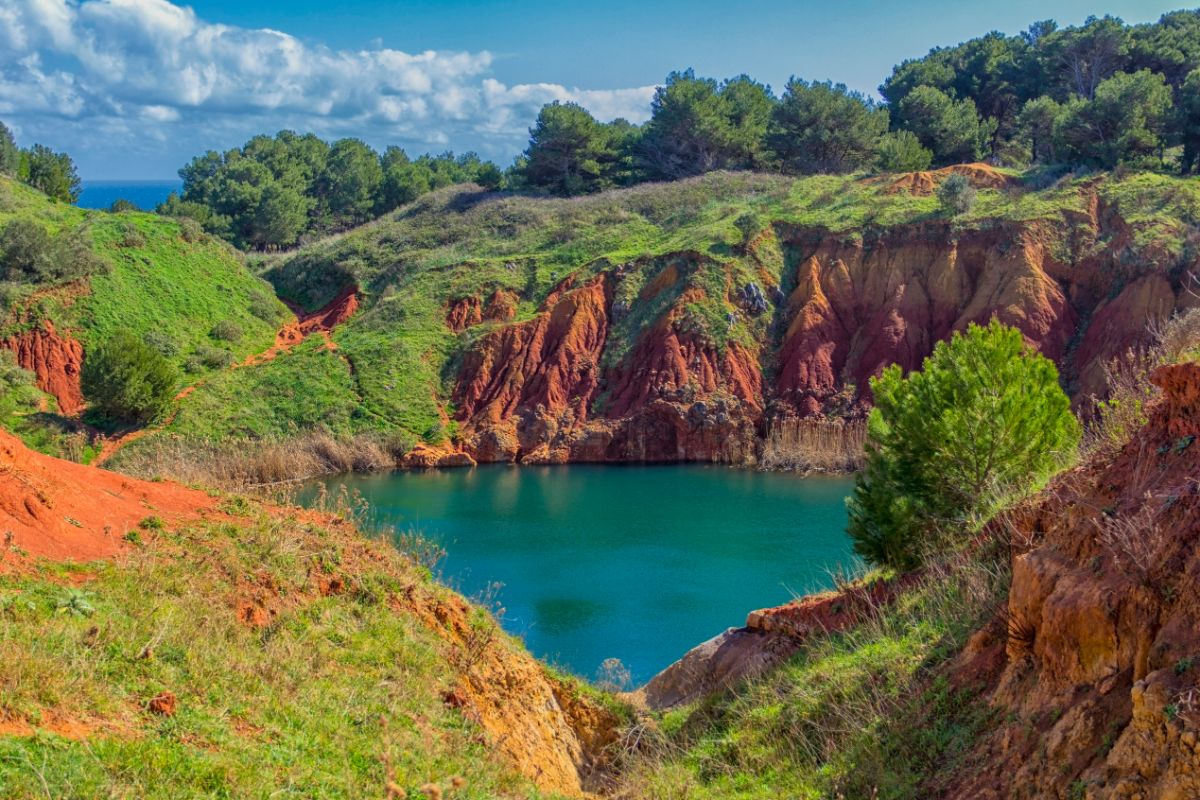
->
[[0, 0, 653, 174]]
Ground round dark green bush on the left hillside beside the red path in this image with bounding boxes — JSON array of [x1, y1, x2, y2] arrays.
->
[[82, 330, 178, 423]]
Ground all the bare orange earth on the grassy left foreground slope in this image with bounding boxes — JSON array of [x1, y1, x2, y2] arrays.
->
[[0, 422, 620, 796]]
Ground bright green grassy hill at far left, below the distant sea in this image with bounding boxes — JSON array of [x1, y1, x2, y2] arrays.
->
[[0, 178, 288, 456]]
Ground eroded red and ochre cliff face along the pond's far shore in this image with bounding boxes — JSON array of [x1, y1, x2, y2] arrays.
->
[[446, 191, 1193, 464]]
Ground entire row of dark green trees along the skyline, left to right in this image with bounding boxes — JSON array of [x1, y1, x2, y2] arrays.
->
[[7, 11, 1200, 249]]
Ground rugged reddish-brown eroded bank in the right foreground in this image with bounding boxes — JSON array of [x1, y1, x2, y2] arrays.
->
[[949, 363, 1200, 800]]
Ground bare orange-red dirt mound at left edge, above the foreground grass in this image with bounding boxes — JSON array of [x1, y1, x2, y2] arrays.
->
[[0, 431, 214, 565]]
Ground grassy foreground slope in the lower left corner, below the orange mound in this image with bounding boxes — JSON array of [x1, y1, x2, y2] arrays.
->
[[0, 498, 535, 799]]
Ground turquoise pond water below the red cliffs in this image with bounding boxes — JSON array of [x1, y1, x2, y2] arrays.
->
[[309, 464, 852, 682]]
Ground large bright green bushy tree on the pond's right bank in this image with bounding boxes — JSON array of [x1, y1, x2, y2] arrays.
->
[[848, 320, 1080, 569]]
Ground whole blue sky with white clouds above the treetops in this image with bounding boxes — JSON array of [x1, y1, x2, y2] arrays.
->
[[0, 0, 1180, 180]]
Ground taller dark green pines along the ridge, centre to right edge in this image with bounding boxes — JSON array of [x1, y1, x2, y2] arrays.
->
[[514, 11, 1200, 194]]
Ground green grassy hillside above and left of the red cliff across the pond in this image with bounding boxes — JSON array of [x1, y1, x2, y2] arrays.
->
[[126, 173, 1200, 455]]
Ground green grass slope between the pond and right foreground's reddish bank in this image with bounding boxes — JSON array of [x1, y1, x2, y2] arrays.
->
[[623, 556, 1007, 800]]
